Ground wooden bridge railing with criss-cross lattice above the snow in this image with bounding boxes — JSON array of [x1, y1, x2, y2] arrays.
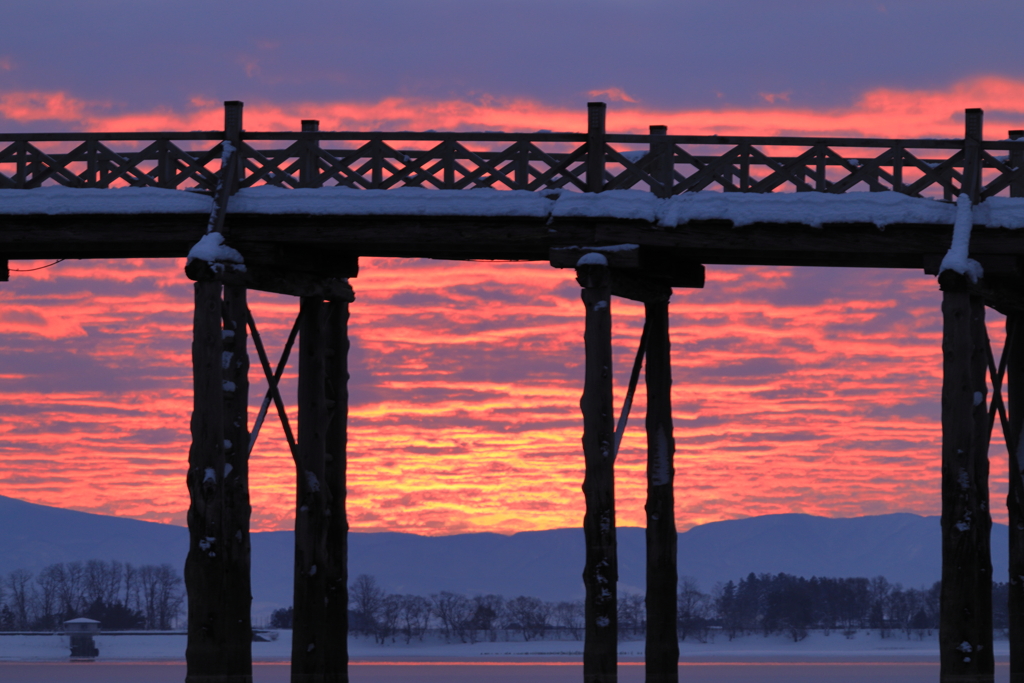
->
[[0, 114, 1024, 200]]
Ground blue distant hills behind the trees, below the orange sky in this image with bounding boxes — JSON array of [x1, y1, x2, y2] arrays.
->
[[0, 496, 1008, 616]]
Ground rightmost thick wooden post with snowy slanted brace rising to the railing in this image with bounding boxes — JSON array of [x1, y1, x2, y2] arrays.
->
[[939, 110, 994, 683]]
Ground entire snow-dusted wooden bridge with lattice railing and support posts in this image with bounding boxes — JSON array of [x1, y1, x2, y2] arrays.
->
[[0, 102, 1024, 683]]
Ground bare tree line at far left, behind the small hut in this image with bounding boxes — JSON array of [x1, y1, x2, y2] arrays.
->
[[0, 560, 185, 631]]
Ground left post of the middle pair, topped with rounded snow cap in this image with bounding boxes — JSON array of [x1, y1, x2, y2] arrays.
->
[[577, 254, 618, 683]]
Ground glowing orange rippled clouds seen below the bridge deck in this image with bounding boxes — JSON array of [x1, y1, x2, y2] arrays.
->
[[0, 254, 1007, 533]]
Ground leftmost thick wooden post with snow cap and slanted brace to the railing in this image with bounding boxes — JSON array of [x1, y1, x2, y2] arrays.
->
[[184, 102, 252, 683]]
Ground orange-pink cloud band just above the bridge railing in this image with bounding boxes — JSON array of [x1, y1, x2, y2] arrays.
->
[[0, 76, 1024, 138]]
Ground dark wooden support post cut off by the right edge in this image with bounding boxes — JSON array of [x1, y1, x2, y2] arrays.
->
[[1004, 311, 1024, 683]]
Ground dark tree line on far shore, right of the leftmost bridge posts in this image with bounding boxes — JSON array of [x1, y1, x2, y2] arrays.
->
[[270, 573, 1009, 644]]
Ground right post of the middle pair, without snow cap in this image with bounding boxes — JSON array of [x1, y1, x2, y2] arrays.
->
[[644, 300, 679, 683]]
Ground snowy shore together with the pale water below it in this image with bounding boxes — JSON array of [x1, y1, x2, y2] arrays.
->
[[0, 631, 1009, 683]]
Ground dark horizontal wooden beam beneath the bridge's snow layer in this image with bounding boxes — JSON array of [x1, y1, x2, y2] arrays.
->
[[0, 214, 1024, 274]]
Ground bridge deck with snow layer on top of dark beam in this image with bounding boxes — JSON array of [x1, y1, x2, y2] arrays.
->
[[0, 186, 1024, 271]]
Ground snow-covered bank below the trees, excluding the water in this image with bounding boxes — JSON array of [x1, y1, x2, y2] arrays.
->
[[0, 631, 1009, 663]]
